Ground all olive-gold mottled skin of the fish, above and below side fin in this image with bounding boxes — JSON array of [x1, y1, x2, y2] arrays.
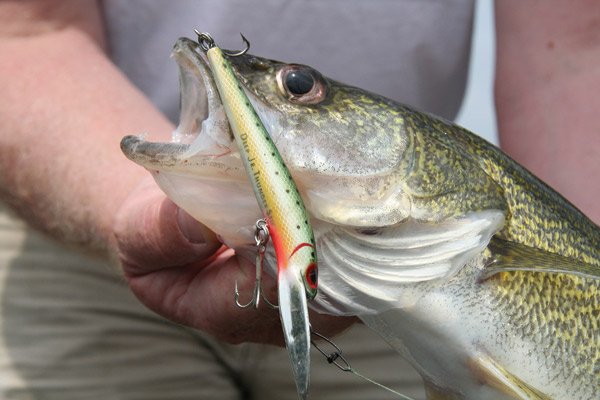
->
[[229, 57, 600, 398]]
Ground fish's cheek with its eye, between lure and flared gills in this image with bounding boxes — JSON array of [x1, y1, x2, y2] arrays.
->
[[225, 50, 418, 228]]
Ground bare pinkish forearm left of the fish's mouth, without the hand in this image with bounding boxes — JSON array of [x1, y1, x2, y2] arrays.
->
[[0, 1, 172, 252]]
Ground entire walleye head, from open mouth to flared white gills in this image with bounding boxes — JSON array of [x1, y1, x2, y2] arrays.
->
[[121, 38, 502, 315]]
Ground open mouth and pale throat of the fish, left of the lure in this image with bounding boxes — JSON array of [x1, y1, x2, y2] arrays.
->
[[121, 38, 261, 248]]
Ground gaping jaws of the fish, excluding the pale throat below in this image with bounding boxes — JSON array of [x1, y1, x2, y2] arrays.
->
[[121, 38, 244, 179]]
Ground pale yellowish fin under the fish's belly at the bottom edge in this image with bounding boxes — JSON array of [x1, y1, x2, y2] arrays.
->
[[471, 354, 552, 400]]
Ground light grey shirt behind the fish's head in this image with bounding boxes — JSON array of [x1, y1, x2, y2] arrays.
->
[[103, 0, 473, 122]]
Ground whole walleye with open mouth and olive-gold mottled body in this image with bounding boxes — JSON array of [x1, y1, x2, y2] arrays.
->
[[121, 39, 600, 400]]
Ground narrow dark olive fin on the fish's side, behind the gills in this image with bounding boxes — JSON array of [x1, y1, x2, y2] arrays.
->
[[480, 238, 600, 280]]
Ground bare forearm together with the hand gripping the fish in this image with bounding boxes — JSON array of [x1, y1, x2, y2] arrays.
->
[[0, 0, 355, 345]]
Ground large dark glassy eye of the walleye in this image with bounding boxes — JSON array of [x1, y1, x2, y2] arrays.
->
[[277, 64, 328, 105]]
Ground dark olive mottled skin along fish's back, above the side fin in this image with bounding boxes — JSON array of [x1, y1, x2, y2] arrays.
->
[[233, 55, 600, 258]]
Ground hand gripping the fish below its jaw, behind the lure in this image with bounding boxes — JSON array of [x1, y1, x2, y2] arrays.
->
[[114, 177, 355, 345]]
